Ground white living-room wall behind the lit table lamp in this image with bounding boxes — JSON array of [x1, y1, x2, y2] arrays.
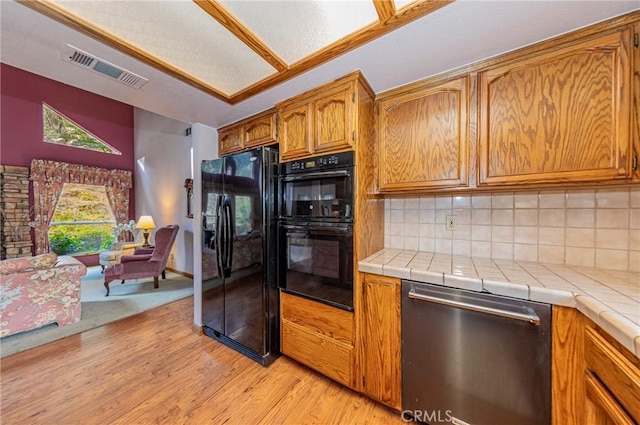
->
[[134, 108, 197, 274]]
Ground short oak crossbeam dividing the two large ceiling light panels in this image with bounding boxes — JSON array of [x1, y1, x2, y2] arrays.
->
[[193, 0, 289, 72]]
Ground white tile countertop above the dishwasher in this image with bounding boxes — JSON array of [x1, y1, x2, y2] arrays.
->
[[358, 248, 640, 358]]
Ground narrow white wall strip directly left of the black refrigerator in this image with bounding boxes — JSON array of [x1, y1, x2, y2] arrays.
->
[[191, 123, 218, 326]]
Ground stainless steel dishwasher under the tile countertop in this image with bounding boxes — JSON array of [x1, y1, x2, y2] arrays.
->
[[402, 280, 551, 425]]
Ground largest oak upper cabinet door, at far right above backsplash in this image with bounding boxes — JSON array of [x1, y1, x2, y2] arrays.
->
[[478, 28, 633, 185]]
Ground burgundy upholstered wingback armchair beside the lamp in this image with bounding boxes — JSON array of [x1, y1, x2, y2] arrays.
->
[[104, 224, 180, 297]]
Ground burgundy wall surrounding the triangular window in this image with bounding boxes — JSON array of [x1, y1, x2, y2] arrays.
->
[[0, 64, 135, 264]]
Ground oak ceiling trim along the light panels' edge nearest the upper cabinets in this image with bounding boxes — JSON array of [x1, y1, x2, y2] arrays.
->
[[231, 0, 455, 104]]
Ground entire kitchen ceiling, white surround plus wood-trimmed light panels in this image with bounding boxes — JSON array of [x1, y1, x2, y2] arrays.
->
[[0, 0, 640, 128]]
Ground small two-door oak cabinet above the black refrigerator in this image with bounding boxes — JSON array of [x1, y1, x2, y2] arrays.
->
[[218, 108, 276, 156]]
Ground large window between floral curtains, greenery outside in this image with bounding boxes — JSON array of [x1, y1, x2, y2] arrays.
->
[[49, 183, 115, 255]]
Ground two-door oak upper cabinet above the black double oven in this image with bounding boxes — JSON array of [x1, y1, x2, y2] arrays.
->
[[276, 72, 373, 161]]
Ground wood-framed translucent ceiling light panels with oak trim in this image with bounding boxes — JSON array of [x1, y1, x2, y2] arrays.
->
[[20, 0, 453, 103]]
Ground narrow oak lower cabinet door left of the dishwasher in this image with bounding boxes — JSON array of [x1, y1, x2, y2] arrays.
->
[[363, 275, 402, 410]]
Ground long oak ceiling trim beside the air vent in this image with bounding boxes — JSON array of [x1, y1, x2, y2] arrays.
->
[[16, 0, 231, 103]]
